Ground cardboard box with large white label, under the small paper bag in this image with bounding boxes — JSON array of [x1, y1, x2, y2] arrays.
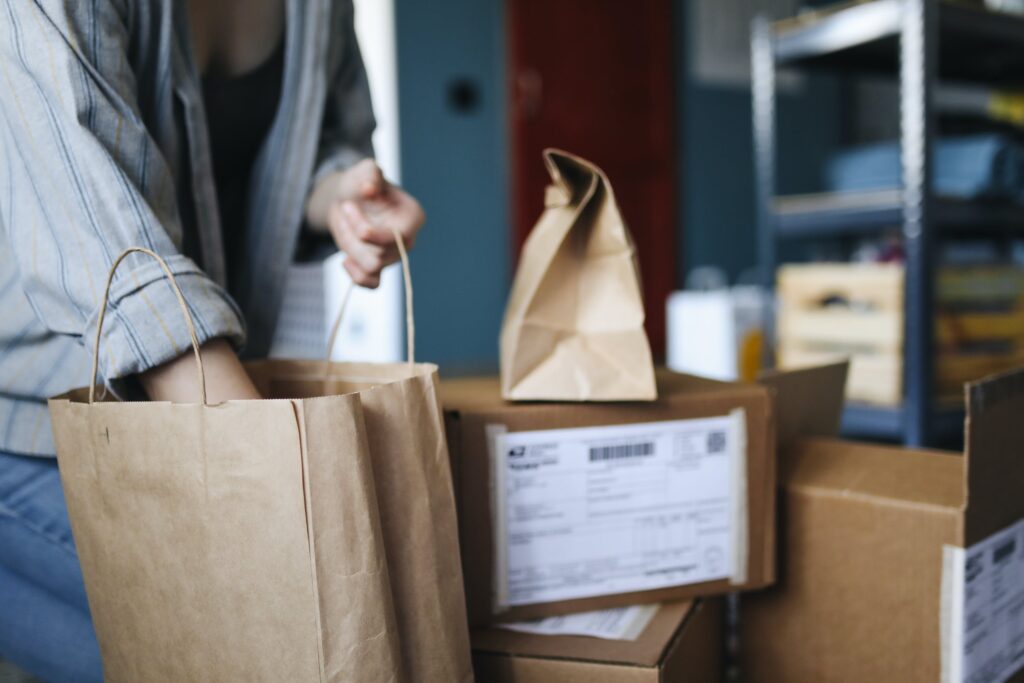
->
[[441, 372, 775, 627]]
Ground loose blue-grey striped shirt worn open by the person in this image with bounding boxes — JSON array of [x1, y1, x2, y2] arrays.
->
[[0, 0, 374, 456]]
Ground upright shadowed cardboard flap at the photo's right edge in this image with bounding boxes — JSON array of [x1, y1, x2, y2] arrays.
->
[[964, 369, 1024, 546]]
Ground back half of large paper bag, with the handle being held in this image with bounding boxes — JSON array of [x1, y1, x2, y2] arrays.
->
[[248, 234, 473, 683]]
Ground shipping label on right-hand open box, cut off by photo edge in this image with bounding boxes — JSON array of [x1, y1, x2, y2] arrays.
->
[[941, 520, 1024, 683]]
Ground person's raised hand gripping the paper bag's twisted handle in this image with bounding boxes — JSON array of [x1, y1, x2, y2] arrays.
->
[[306, 159, 426, 289]]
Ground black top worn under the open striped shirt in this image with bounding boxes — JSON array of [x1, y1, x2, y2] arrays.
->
[[203, 40, 285, 278]]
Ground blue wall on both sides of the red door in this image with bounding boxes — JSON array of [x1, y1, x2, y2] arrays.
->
[[395, 0, 843, 374]]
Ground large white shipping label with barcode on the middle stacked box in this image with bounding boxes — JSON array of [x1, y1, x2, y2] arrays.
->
[[490, 410, 746, 609]]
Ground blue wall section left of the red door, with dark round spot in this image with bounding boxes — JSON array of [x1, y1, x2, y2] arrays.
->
[[395, 0, 510, 374]]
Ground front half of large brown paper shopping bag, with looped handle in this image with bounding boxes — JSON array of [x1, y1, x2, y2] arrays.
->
[[50, 249, 401, 683]]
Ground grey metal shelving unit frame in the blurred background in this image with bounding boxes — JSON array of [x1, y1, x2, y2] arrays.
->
[[752, 0, 1024, 445]]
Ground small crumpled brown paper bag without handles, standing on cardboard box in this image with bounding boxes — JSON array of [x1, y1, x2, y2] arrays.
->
[[501, 150, 657, 400]]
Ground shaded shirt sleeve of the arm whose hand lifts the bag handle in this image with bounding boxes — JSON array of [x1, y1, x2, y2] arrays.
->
[[313, 0, 377, 184]]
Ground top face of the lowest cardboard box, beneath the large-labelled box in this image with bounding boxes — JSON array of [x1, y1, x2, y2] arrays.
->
[[472, 600, 696, 667]]
